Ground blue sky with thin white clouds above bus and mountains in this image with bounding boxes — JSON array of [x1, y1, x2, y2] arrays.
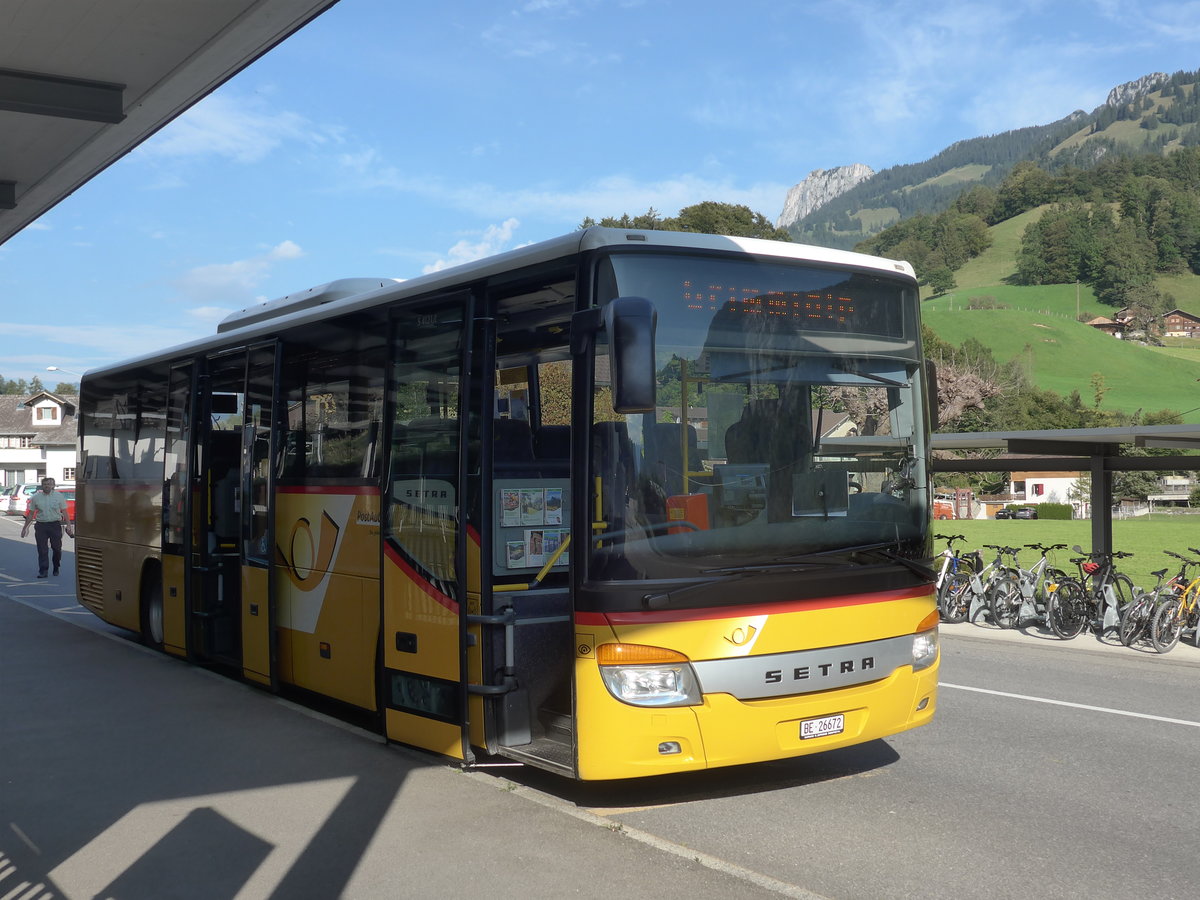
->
[[0, 0, 1200, 386]]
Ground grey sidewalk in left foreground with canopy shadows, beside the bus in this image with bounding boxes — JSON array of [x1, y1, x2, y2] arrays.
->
[[0, 595, 808, 900]]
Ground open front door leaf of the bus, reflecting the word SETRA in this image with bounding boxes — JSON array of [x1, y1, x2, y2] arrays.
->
[[380, 294, 478, 760]]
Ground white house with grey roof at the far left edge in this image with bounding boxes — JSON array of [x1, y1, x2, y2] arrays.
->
[[0, 391, 79, 486]]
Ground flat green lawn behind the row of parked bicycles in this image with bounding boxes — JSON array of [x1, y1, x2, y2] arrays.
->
[[934, 512, 1200, 589]]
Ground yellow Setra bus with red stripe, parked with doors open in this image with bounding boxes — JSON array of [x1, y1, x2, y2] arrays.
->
[[76, 228, 938, 780]]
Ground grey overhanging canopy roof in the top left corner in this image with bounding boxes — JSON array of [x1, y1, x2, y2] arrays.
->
[[0, 0, 337, 244]]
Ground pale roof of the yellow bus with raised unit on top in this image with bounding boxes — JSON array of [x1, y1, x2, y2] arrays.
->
[[86, 226, 916, 377]]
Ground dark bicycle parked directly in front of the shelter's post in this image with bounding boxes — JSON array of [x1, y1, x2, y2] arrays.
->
[[1046, 545, 1134, 641]]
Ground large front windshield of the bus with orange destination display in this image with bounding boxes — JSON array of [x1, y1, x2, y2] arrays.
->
[[589, 253, 930, 580]]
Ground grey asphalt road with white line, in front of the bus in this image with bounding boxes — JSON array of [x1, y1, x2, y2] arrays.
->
[[0, 521, 1200, 900]]
